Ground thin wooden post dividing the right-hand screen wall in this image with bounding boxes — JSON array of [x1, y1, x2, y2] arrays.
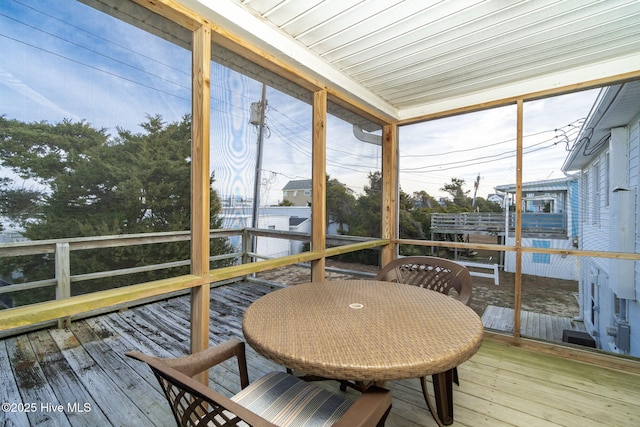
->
[[513, 98, 524, 339]]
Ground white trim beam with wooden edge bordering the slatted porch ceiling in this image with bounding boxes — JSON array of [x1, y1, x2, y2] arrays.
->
[[156, 0, 640, 124]]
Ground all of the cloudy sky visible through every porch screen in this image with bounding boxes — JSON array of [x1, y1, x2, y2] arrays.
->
[[0, 0, 596, 213]]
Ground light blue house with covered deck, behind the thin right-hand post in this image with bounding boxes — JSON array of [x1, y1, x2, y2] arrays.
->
[[496, 177, 578, 280]]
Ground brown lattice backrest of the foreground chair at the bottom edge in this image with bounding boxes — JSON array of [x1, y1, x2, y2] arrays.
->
[[127, 352, 275, 427]]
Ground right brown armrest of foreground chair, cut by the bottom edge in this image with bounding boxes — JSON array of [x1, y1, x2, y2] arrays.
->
[[333, 386, 391, 427]]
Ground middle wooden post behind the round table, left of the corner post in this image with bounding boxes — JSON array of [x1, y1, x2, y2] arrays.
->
[[311, 90, 327, 282]]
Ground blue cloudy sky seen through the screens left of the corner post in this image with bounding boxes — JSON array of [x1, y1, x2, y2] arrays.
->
[[0, 0, 380, 210]]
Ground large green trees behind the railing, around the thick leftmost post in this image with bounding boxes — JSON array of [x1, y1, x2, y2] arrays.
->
[[0, 116, 230, 304]]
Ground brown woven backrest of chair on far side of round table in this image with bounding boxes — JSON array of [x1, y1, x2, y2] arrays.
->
[[375, 256, 472, 305]]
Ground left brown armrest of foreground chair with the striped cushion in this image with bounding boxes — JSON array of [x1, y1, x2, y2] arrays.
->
[[126, 338, 249, 388]]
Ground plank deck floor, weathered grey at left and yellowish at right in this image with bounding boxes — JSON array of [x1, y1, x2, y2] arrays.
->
[[0, 283, 640, 427]]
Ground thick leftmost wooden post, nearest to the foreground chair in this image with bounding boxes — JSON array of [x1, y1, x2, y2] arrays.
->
[[191, 26, 211, 378]]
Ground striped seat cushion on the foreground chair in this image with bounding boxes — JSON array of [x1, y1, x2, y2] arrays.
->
[[232, 372, 353, 427]]
